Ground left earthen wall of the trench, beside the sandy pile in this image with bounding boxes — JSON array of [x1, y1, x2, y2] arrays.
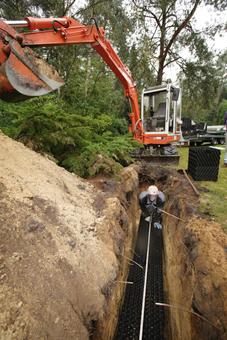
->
[[92, 166, 140, 340]]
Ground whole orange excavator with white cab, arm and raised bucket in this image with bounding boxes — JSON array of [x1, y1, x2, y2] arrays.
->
[[0, 17, 180, 162]]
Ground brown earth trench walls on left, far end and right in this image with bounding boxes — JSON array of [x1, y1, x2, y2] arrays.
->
[[93, 166, 227, 340]]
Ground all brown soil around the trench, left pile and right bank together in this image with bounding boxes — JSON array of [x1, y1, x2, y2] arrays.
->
[[0, 134, 227, 340]]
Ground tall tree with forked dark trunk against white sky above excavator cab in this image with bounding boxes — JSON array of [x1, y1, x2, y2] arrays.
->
[[129, 0, 225, 84]]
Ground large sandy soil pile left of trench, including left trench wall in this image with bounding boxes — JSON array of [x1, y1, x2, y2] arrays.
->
[[0, 134, 139, 340]]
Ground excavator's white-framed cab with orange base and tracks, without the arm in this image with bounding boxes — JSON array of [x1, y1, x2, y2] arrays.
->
[[131, 83, 181, 165]]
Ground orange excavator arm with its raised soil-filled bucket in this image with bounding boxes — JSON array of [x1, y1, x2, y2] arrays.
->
[[0, 17, 144, 143]]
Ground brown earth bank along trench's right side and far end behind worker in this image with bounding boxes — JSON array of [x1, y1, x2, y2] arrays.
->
[[140, 166, 227, 340]]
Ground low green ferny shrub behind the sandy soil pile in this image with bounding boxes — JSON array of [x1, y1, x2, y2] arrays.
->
[[0, 95, 137, 177]]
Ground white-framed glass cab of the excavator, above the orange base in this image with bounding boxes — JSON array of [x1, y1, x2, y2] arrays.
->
[[141, 83, 181, 136]]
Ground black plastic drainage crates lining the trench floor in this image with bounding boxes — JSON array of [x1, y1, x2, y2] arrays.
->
[[115, 218, 164, 340]]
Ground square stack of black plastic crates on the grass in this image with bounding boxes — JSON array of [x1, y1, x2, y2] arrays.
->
[[188, 147, 220, 181]]
